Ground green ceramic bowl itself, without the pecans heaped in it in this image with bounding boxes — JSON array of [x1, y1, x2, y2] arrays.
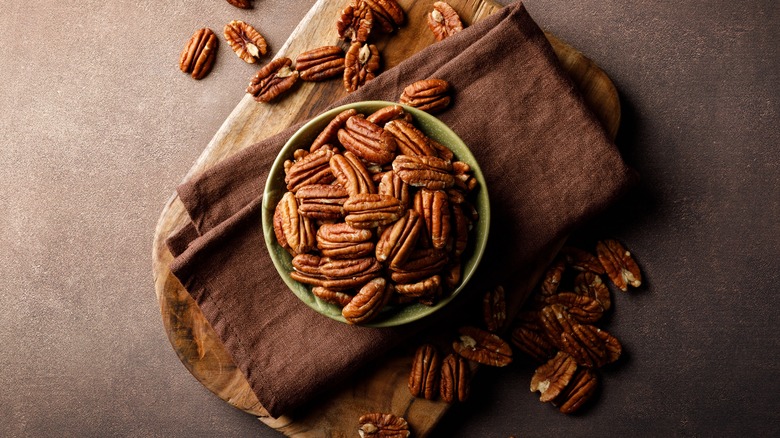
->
[[263, 101, 490, 327]]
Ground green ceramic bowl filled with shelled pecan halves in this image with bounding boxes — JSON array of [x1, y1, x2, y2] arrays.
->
[[262, 101, 490, 327]]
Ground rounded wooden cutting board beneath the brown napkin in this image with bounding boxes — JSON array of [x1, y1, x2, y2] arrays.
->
[[152, 0, 620, 437]]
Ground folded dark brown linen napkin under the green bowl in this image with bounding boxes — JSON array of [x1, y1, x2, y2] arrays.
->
[[169, 3, 633, 416]]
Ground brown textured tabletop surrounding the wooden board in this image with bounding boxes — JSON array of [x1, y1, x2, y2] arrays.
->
[[0, 0, 780, 437]]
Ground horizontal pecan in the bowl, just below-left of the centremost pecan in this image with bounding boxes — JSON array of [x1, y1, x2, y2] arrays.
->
[[317, 223, 374, 259]]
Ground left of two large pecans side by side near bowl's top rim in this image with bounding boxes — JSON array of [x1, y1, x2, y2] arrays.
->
[[338, 116, 396, 165]]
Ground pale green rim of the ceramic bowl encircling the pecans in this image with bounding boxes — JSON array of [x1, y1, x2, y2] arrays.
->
[[261, 100, 491, 328]]
